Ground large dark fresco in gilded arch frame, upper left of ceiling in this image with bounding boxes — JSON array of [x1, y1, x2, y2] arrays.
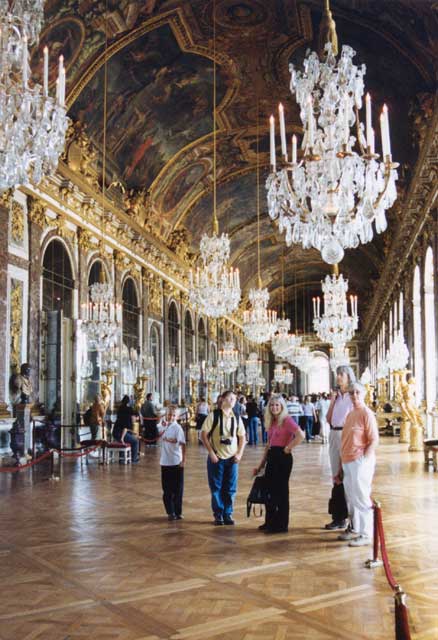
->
[[70, 25, 225, 190]]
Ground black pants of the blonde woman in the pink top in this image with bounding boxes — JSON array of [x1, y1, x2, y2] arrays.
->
[[265, 447, 293, 531]]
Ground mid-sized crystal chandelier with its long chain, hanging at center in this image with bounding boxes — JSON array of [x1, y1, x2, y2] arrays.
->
[[189, 11, 240, 318]]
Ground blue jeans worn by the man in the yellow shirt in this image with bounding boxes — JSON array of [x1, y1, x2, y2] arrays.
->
[[207, 457, 239, 519]]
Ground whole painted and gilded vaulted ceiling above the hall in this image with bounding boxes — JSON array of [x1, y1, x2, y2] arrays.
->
[[34, 0, 438, 330]]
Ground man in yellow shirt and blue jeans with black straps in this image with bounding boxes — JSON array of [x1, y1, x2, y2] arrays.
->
[[201, 391, 246, 526]]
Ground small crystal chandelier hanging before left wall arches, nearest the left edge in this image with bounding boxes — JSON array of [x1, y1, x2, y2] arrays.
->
[[82, 272, 122, 353]]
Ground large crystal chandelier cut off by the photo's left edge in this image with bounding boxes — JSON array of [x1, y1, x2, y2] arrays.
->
[[0, 0, 69, 192]]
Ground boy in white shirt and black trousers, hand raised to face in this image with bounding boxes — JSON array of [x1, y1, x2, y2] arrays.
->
[[158, 406, 186, 520]]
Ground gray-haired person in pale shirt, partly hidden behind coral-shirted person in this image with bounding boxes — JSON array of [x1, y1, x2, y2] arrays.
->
[[325, 365, 356, 531]]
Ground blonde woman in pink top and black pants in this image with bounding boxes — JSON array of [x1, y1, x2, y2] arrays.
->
[[254, 395, 304, 533]]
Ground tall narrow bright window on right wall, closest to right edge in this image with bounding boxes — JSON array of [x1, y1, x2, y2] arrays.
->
[[424, 247, 436, 411]]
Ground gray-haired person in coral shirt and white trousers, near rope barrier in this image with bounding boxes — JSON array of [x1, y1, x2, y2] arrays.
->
[[339, 382, 379, 547]]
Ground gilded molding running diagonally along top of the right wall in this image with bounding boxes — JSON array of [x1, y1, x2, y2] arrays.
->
[[363, 102, 438, 340]]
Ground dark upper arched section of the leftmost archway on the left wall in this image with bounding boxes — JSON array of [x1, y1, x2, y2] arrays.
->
[[42, 240, 74, 318]]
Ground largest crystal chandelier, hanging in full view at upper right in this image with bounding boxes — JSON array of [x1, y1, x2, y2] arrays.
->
[[266, 3, 398, 264]]
